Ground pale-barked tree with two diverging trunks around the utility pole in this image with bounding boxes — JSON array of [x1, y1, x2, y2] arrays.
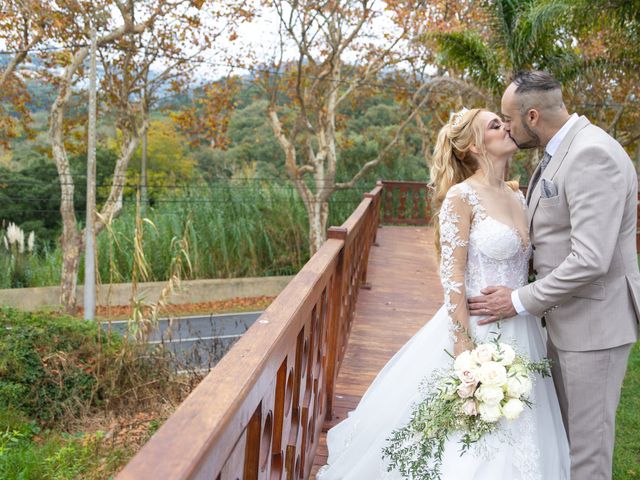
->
[[26, 0, 248, 310]]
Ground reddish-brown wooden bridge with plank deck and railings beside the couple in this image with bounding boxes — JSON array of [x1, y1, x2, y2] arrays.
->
[[118, 182, 640, 480]]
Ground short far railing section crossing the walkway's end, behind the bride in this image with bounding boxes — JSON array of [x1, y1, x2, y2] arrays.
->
[[382, 180, 432, 225]]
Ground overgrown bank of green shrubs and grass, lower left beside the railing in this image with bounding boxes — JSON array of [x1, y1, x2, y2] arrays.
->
[[0, 307, 185, 480]]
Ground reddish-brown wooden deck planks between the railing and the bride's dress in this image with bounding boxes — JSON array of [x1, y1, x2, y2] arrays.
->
[[311, 226, 443, 478]]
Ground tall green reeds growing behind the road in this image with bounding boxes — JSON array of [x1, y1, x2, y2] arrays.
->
[[0, 179, 363, 288]]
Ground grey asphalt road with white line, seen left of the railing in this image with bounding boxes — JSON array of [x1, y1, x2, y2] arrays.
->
[[102, 312, 262, 371]]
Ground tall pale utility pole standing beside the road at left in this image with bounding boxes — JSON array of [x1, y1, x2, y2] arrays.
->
[[84, 27, 97, 320]]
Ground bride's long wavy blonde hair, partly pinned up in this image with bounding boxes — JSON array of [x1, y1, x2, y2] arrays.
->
[[429, 108, 517, 257]]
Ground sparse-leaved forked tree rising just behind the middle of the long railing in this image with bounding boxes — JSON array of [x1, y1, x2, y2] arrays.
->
[[260, 0, 438, 254]]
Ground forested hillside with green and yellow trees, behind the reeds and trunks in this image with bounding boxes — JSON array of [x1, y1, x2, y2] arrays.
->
[[0, 77, 428, 246]]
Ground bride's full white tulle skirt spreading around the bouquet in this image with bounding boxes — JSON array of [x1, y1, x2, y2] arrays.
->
[[316, 307, 570, 480]]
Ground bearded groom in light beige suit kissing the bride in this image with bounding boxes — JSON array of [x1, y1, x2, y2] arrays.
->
[[469, 72, 640, 480]]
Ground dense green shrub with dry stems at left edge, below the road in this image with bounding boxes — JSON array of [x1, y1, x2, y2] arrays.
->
[[0, 308, 122, 423]]
